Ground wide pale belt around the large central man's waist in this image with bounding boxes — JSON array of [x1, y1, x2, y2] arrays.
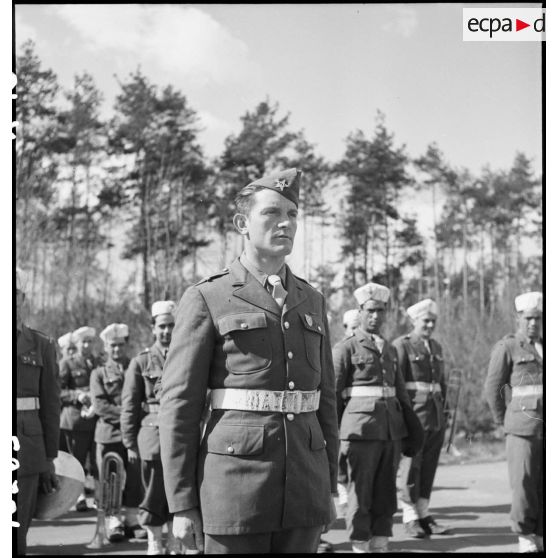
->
[[211, 388, 320, 415]]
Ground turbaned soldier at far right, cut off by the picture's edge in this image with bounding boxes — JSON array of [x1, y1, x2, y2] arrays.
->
[[485, 292, 544, 552]]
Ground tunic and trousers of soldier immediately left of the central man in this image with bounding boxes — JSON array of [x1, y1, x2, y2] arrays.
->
[[120, 343, 171, 526]]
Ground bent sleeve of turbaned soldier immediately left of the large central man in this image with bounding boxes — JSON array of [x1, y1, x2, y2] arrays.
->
[[120, 358, 145, 449]]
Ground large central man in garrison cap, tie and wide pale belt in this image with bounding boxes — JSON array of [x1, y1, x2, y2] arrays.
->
[[159, 169, 338, 554]]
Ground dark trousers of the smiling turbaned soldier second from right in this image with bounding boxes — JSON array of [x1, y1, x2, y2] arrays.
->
[[399, 430, 445, 505]]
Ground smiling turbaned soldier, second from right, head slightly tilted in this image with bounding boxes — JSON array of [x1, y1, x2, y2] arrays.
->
[[393, 298, 448, 538]]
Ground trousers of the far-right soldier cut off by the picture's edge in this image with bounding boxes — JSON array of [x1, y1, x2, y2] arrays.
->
[[506, 434, 544, 536]]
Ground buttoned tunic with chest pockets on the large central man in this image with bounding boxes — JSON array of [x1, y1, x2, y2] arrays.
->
[[159, 260, 338, 535]]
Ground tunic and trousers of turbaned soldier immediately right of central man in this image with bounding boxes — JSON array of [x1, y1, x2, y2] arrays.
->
[[333, 328, 410, 541]]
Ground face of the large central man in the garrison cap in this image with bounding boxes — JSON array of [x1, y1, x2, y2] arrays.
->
[[238, 188, 298, 257]]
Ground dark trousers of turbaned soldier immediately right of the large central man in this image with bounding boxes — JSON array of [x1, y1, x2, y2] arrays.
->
[[340, 440, 401, 541]]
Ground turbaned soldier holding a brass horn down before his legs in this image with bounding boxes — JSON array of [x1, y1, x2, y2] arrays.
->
[[90, 323, 147, 542]]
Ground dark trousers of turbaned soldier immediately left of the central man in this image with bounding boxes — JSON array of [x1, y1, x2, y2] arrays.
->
[[138, 460, 172, 527]]
